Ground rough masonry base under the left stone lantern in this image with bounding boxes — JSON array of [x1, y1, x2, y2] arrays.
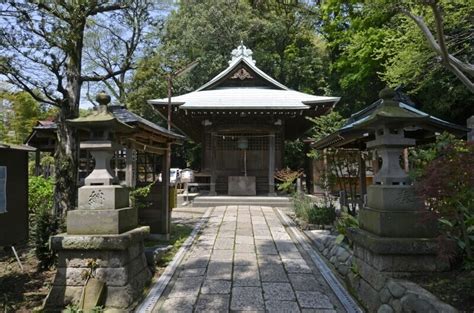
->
[[45, 227, 151, 312]]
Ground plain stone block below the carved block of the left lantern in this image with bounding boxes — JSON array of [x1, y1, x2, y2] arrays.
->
[[67, 208, 138, 235]]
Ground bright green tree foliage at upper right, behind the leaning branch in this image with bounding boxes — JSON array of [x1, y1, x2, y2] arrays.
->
[[321, 0, 474, 123]]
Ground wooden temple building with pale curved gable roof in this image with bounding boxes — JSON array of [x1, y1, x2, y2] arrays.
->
[[148, 44, 339, 195]]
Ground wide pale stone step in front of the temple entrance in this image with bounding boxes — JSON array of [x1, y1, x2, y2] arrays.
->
[[193, 196, 292, 207]]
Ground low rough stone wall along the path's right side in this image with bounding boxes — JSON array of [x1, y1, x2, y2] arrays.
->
[[306, 230, 458, 313]]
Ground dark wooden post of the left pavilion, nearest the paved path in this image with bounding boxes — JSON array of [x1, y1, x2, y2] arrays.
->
[[158, 144, 171, 236]]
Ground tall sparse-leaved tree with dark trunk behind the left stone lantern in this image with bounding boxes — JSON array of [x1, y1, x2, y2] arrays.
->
[[0, 0, 159, 213]]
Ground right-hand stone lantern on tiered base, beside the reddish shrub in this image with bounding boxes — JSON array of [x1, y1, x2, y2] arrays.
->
[[349, 89, 449, 277]]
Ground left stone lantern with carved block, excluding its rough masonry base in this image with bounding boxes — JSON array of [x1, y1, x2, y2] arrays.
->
[[67, 92, 137, 234]]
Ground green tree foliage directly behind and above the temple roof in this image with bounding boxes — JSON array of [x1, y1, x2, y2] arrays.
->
[[128, 0, 328, 113]]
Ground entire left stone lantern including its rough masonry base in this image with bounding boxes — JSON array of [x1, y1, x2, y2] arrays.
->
[[45, 92, 151, 310]]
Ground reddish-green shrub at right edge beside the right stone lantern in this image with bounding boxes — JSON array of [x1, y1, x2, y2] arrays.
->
[[415, 135, 474, 263]]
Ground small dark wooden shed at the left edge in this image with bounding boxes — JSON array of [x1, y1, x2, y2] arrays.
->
[[0, 143, 36, 246]]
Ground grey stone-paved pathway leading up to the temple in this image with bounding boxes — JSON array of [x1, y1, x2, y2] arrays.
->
[[154, 206, 345, 313]]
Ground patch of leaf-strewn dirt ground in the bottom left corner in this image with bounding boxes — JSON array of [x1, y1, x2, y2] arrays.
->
[[0, 245, 55, 313]]
